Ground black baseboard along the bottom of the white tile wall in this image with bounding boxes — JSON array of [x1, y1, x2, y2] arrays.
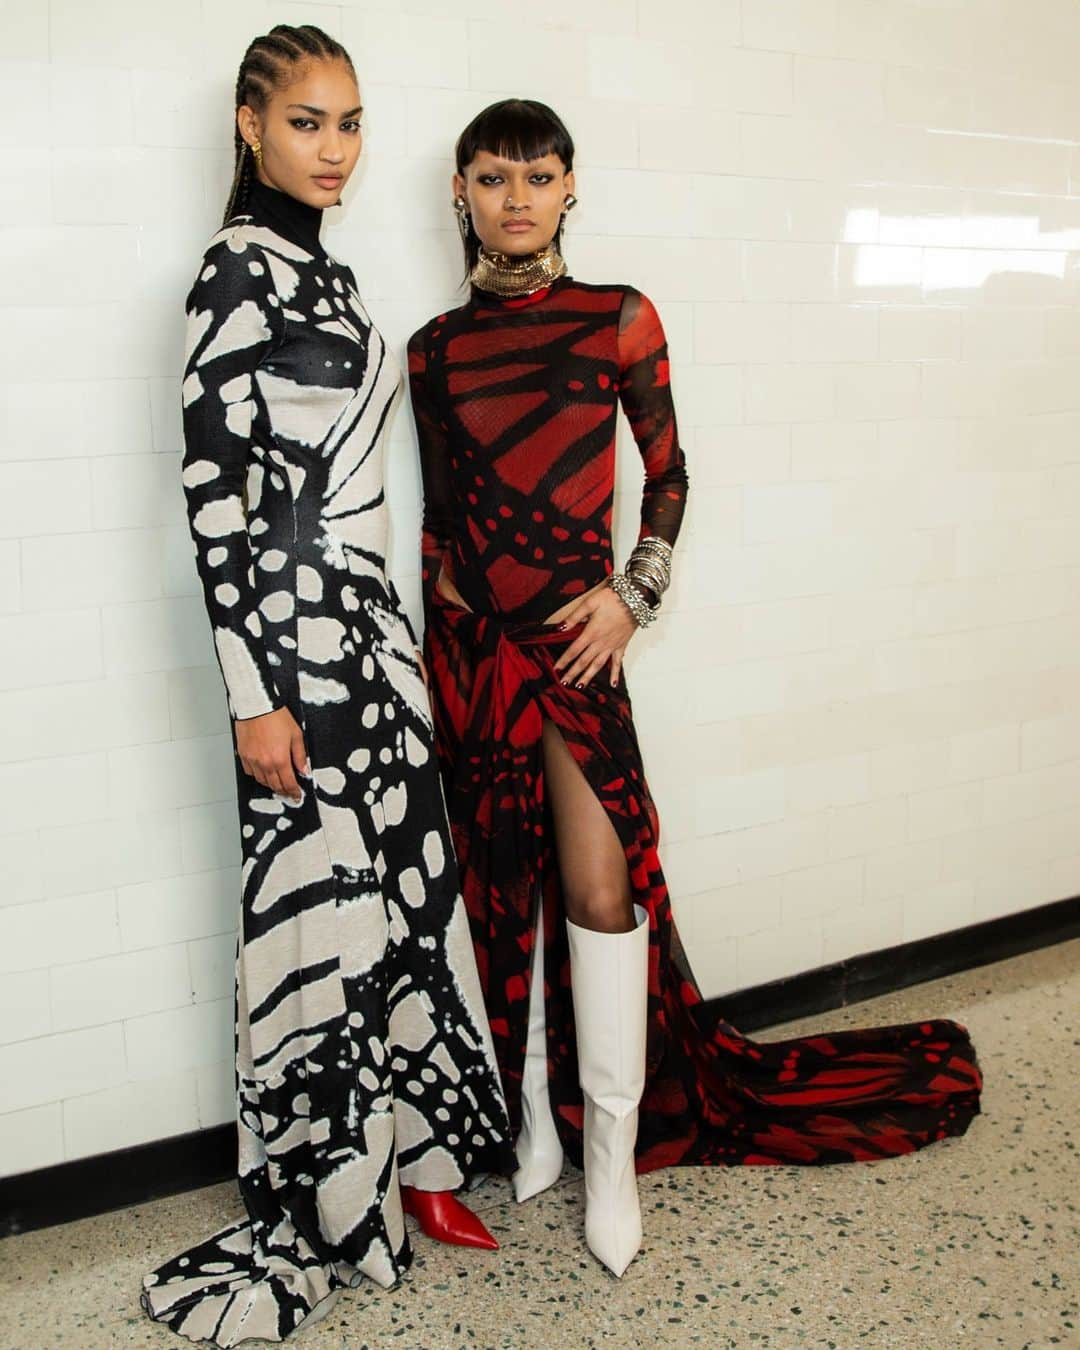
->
[[0, 896, 1080, 1238]]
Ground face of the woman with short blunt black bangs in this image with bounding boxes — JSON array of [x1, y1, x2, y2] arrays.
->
[[454, 150, 574, 254]]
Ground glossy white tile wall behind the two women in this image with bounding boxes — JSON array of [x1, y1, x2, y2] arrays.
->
[[0, 0, 1080, 1175]]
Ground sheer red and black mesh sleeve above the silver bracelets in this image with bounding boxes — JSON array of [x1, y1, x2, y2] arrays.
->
[[618, 289, 687, 544]]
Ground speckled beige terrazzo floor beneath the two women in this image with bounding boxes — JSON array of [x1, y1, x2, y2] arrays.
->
[[0, 941, 1080, 1350]]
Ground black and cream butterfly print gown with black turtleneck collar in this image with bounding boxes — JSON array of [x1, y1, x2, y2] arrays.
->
[[143, 182, 514, 1346]]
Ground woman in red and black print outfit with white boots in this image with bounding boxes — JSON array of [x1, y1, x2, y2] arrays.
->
[[409, 100, 981, 1274]]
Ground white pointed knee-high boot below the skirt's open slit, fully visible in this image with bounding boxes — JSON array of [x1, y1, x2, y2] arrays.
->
[[566, 905, 649, 1274]]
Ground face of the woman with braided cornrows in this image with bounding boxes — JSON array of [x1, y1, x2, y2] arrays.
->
[[236, 61, 363, 207]]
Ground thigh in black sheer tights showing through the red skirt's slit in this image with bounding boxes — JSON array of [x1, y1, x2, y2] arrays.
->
[[544, 718, 635, 933]]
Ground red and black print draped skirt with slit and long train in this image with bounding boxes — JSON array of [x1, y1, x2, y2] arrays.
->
[[425, 589, 981, 1172]]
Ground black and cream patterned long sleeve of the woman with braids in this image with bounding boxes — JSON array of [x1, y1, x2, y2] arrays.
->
[[184, 236, 285, 718]]
